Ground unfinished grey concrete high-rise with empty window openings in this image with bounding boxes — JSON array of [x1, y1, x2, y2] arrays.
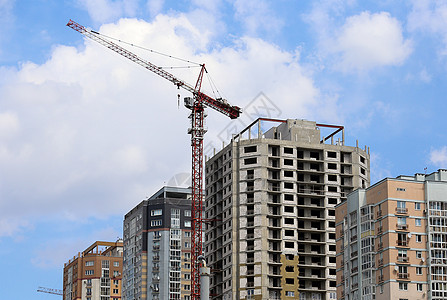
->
[[204, 119, 369, 300]]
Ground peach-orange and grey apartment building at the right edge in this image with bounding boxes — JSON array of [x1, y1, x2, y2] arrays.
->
[[336, 169, 447, 300]]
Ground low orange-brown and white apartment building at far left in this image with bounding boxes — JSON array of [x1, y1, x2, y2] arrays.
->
[[63, 240, 123, 300]]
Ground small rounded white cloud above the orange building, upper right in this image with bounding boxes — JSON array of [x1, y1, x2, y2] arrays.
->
[[333, 12, 412, 72]]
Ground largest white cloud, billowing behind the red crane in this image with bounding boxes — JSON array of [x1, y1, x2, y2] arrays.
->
[[0, 14, 322, 235]]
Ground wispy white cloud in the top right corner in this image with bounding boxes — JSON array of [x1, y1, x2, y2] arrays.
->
[[408, 0, 447, 55]]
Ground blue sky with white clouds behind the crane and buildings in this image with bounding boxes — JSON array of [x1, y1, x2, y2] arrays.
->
[[0, 0, 447, 299]]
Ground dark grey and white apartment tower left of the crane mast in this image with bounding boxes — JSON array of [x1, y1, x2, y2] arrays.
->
[[123, 187, 191, 300]]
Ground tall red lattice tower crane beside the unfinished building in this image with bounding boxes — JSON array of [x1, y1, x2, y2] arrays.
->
[[67, 20, 241, 300]]
